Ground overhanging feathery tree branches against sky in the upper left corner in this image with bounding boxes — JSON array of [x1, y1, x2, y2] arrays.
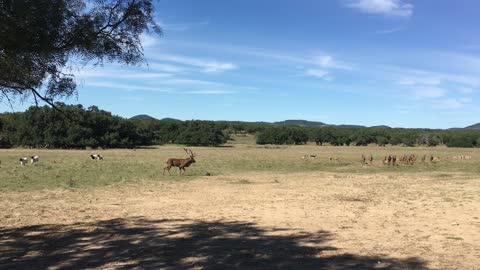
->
[[0, 0, 161, 106]]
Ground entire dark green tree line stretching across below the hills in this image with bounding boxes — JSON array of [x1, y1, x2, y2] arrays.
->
[[0, 103, 480, 149]]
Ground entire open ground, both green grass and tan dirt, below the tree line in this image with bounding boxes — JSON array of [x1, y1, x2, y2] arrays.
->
[[0, 137, 480, 270]]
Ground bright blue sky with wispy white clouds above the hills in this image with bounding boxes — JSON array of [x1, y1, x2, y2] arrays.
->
[[0, 0, 480, 128]]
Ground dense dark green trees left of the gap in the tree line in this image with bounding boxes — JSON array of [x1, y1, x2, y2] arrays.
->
[[0, 103, 229, 149]]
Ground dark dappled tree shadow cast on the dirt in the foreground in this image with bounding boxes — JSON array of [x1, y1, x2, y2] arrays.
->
[[0, 218, 426, 270]]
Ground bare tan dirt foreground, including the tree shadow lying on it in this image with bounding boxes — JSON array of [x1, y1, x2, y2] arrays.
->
[[0, 172, 480, 269]]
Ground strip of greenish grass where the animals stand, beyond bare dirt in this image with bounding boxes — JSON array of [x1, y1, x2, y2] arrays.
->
[[0, 137, 480, 190]]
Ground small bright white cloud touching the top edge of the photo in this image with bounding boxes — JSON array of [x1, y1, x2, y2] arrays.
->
[[345, 0, 414, 17]]
